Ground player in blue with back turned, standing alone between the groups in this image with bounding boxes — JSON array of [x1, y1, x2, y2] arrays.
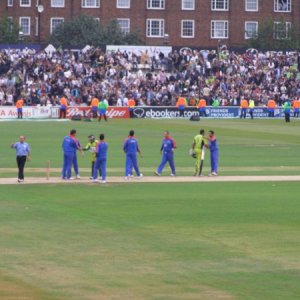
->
[[123, 130, 143, 179]]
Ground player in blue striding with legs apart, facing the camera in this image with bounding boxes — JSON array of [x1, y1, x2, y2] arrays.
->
[[155, 131, 176, 176]]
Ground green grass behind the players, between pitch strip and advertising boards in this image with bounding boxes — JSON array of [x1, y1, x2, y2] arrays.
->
[[0, 119, 300, 176]]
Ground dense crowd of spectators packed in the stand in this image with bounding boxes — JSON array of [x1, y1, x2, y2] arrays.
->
[[0, 48, 300, 106]]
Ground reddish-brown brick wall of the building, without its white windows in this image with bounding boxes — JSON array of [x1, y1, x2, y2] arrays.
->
[[0, 0, 300, 47]]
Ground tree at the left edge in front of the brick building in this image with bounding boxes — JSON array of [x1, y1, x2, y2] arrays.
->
[[0, 16, 20, 44]]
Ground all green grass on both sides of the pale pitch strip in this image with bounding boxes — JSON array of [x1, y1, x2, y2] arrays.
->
[[0, 120, 300, 300]]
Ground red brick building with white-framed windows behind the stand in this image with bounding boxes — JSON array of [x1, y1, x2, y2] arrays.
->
[[0, 0, 300, 47]]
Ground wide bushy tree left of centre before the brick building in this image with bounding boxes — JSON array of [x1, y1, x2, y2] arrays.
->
[[49, 15, 142, 47]]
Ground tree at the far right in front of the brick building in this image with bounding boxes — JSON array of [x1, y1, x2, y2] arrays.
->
[[246, 18, 300, 50]]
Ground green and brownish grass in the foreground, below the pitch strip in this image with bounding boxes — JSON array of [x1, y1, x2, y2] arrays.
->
[[0, 183, 300, 300]]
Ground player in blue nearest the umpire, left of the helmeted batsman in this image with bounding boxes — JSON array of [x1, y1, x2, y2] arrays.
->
[[62, 129, 80, 179]]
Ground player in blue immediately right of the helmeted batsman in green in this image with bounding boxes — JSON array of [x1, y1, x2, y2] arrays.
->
[[93, 133, 108, 183]]
